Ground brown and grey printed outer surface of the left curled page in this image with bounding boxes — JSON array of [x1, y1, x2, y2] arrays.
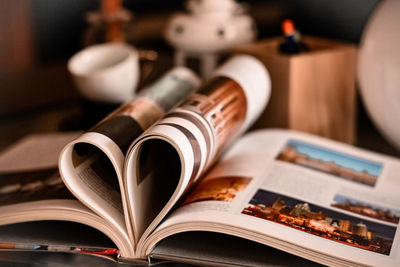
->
[[88, 67, 200, 153]]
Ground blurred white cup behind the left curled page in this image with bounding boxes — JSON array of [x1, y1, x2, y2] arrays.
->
[[68, 43, 139, 103]]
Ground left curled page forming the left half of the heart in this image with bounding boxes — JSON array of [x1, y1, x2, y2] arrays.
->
[[59, 67, 200, 245]]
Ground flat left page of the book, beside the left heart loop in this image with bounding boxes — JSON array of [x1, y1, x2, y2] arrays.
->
[[0, 132, 80, 206]]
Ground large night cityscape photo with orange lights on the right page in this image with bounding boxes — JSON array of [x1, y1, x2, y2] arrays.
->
[[242, 189, 397, 255]]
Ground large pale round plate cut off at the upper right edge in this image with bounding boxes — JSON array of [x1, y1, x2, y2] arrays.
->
[[358, 0, 400, 149]]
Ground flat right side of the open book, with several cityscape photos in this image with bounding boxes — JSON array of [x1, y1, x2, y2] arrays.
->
[[143, 130, 400, 266]]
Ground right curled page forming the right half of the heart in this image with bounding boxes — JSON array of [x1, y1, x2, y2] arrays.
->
[[125, 55, 270, 243]]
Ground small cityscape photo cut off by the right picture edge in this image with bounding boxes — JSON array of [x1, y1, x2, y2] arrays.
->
[[331, 195, 400, 224]]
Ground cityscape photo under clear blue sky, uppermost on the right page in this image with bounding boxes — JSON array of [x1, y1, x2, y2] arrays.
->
[[277, 140, 382, 186]]
